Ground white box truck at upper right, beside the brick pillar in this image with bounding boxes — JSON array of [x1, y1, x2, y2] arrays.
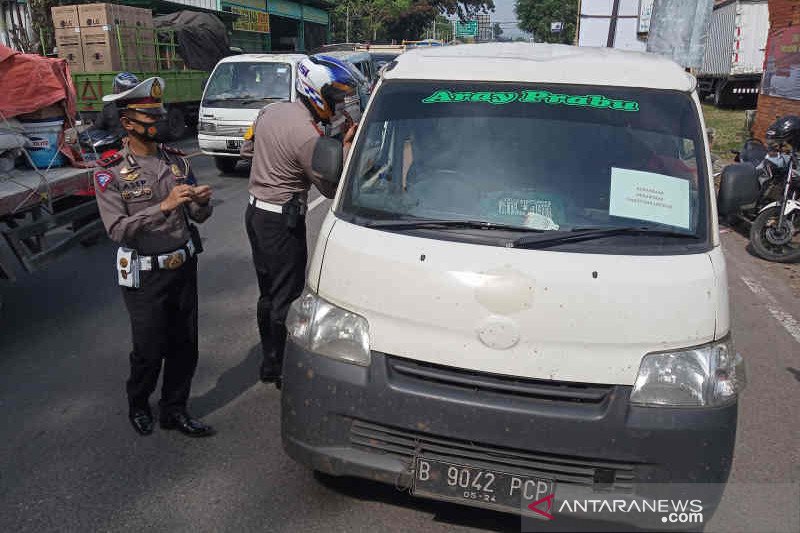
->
[[695, 0, 769, 109]]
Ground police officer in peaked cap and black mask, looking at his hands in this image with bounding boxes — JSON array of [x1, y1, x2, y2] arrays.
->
[[94, 78, 213, 437]]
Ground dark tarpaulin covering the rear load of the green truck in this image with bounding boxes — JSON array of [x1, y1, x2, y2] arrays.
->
[[153, 11, 231, 71]]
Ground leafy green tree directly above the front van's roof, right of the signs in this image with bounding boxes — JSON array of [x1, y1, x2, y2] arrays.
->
[[514, 0, 578, 44]]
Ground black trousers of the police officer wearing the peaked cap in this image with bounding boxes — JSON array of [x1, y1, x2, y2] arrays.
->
[[122, 257, 197, 413]]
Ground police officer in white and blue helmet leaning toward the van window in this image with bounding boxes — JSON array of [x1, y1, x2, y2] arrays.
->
[[242, 56, 357, 386]]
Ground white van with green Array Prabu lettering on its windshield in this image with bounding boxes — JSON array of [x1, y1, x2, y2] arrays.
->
[[282, 44, 745, 526]]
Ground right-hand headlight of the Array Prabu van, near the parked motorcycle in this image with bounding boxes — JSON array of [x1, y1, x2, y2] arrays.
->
[[631, 338, 746, 407]]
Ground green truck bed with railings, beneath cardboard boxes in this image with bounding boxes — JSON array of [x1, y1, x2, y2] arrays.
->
[[72, 25, 209, 139]]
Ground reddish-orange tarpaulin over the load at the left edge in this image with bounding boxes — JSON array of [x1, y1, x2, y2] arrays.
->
[[0, 45, 76, 119]]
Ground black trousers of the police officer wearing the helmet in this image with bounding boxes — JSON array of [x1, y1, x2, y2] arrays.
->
[[245, 205, 308, 365]]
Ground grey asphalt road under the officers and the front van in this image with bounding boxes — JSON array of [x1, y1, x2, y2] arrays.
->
[[0, 147, 800, 532]]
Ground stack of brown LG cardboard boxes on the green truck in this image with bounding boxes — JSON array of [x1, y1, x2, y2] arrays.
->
[[52, 3, 156, 72]]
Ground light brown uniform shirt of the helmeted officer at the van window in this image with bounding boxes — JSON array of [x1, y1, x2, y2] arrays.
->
[[249, 101, 336, 204]]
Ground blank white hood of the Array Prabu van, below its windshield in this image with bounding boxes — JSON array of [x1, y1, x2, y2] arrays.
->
[[318, 220, 727, 385]]
